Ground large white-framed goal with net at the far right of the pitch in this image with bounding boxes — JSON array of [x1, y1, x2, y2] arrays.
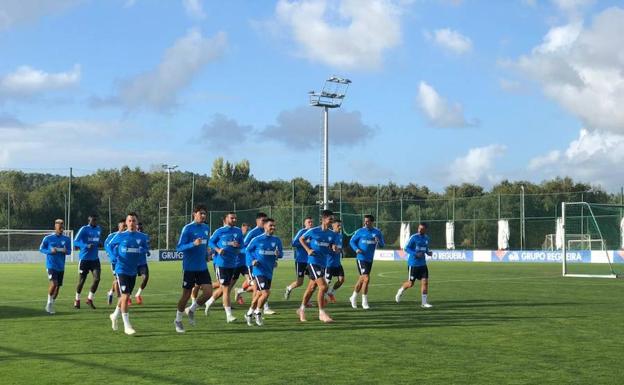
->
[[561, 202, 624, 278]]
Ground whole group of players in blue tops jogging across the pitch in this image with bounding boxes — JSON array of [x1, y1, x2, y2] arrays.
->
[[40, 205, 432, 335]]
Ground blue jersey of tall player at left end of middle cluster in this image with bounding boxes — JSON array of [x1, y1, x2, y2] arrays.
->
[[176, 222, 210, 271]]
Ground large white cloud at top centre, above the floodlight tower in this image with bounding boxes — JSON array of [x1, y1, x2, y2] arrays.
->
[[275, 0, 401, 70]]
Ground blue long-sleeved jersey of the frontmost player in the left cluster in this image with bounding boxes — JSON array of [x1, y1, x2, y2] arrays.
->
[[108, 231, 149, 275]]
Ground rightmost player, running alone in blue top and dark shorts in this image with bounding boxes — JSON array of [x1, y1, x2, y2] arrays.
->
[[394, 223, 433, 309]]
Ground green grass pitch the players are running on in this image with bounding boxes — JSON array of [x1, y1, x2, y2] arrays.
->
[[0, 260, 624, 385]]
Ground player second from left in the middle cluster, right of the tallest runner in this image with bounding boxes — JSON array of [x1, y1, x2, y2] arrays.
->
[[206, 212, 243, 323]]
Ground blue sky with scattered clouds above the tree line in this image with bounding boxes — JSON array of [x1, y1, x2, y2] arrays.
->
[[0, 0, 624, 190]]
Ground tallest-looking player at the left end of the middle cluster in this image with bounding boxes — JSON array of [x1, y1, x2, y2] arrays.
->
[[173, 205, 212, 333]]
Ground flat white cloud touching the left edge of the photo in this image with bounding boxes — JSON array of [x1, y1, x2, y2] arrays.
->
[[0, 65, 80, 100]]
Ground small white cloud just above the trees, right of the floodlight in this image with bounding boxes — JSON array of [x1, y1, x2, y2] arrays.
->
[[443, 144, 507, 186]]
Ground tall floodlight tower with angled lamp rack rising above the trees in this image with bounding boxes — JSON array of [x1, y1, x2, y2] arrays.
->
[[309, 76, 351, 210]]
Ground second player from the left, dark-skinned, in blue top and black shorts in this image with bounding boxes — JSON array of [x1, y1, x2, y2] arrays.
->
[[74, 214, 102, 309]]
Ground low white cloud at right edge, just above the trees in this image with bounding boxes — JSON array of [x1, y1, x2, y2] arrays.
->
[[529, 129, 624, 190]]
